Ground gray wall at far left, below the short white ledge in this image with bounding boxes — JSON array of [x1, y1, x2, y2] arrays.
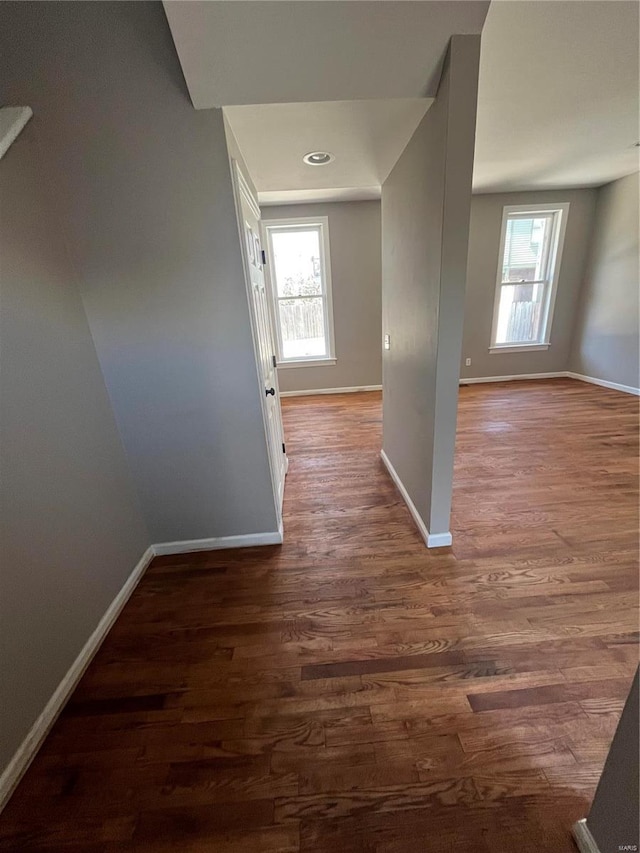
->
[[0, 115, 150, 773]]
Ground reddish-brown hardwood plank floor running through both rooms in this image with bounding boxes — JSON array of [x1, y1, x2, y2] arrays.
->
[[0, 380, 638, 853]]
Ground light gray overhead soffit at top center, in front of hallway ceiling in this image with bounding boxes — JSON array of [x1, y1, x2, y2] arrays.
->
[[164, 0, 489, 109]]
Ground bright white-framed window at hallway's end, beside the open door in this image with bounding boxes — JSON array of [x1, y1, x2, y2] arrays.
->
[[264, 217, 335, 367]]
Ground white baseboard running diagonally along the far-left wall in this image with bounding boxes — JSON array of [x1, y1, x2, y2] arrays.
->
[[0, 547, 155, 811]]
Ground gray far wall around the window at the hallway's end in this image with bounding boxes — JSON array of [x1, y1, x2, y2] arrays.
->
[[262, 201, 382, 391]]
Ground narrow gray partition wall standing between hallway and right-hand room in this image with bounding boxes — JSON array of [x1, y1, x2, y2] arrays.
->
[[382, 36, 480, 534]]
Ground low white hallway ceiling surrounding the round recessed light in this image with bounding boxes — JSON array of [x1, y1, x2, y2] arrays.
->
[[225, 98, 433, 204]]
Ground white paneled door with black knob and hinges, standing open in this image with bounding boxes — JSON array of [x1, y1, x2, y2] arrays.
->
[[235, 163, 287, 513]]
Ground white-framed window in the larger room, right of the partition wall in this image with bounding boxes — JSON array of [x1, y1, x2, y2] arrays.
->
[[491, 204, 569, 352]]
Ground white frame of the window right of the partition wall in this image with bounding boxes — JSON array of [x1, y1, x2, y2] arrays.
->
[[489, 202, 570, 355]]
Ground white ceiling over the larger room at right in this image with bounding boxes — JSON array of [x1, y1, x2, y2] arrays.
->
[[473, 0, 640, 192]]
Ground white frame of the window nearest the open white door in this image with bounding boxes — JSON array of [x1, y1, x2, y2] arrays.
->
[[262, 216, 337, 368]]
